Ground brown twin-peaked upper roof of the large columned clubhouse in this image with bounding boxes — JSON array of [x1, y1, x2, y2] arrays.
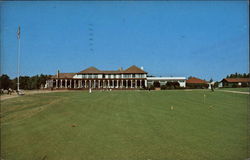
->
[[78, 65, 147, 74]]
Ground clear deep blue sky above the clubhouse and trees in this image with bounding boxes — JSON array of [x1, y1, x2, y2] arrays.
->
[[0, 0, 249, 81]]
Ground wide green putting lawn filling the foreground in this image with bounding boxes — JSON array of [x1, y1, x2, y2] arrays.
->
[[1, 90, 250, 160]]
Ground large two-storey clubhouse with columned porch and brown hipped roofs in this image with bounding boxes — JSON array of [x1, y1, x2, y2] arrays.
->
[[45, 65, 147, 89]]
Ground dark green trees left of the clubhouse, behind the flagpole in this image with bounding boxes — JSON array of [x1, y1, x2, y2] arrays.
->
[[0, 74, 51, 90]]
